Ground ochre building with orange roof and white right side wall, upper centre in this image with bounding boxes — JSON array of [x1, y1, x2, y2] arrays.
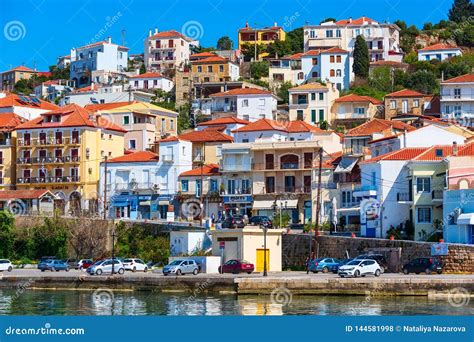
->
[[191, 55, 240, 83]]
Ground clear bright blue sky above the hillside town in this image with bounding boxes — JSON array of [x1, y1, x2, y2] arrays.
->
[[0, 0, 452, 71]]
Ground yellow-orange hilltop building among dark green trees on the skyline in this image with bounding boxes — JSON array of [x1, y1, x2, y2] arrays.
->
[[238, 23, 286, 59]]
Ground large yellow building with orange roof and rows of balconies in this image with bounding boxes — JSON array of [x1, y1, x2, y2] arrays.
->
[[15, 104, 126, 214]]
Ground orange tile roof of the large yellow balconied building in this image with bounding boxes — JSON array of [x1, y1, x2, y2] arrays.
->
[[15, 104, 127, 133]]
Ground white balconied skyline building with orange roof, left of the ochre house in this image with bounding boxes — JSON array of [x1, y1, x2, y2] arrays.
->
[[144, 29, 195, 72]]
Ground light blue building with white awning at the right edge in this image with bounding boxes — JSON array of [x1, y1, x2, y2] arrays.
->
[[443, 189, 474, 244]]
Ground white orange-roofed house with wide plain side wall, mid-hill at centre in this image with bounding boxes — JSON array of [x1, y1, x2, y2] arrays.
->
[[210, 88, 278, 121]]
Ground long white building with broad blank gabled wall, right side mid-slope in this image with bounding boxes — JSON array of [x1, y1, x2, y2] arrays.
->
[[369, 125, 465, 157]]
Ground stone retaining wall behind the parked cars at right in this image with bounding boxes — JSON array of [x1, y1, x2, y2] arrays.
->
[[282, 234, 474, 273]]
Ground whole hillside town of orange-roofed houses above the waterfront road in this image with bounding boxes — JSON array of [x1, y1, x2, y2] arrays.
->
[[0, 0, 474, 255]]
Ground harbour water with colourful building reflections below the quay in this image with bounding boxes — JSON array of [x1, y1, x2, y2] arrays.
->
[[0, 290, 474, 316]]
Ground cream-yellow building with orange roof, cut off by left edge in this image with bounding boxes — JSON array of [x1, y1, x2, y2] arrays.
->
[[0, 113, 26, 190]]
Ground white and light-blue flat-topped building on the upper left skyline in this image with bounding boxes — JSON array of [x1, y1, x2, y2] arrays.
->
[[70, 38, 128, 88]]
